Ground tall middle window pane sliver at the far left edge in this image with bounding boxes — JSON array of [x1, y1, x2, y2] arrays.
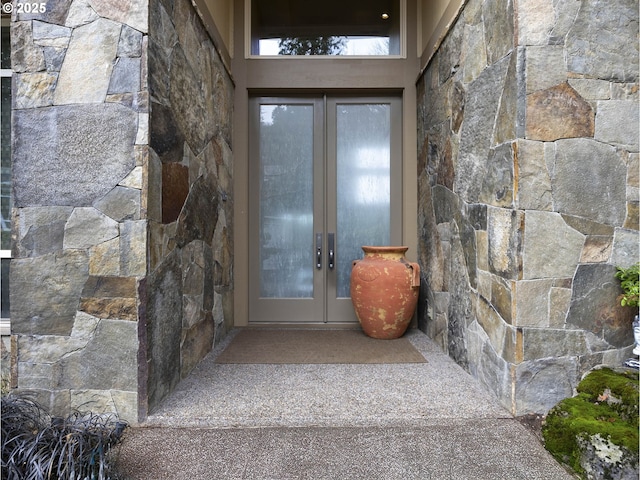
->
[[0, 77, 11, 250]]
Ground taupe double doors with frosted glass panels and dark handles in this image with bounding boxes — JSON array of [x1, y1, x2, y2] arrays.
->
[[249, 96, 402, 323]]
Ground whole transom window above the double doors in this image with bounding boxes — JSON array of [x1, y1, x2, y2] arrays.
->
[[247, 0, 404, 56]]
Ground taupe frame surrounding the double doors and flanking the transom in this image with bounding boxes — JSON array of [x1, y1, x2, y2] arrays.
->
[[231, 0, 421, 328]]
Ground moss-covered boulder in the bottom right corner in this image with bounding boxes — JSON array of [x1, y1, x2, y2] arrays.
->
[[542, 368, 639, 480]]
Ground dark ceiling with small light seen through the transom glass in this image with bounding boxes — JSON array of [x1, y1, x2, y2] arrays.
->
[[252, 0, 399, 38]]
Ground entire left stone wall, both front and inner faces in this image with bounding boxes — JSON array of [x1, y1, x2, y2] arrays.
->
[[11, 0, 233, 422]]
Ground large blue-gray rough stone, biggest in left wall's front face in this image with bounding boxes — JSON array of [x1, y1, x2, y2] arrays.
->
[[13, 104, 138, 207]]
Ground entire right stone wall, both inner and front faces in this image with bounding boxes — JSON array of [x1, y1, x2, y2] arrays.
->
[[418, 0, 639, 415]]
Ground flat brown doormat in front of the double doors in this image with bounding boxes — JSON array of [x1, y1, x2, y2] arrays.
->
[[216, 328, 426, 364]]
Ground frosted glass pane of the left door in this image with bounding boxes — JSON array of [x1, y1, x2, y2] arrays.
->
[[260, 105, 314, 298]]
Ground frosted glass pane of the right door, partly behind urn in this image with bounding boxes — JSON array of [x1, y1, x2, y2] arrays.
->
[[336, 104, 391, 297]]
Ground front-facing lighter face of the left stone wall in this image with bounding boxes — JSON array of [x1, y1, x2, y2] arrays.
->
[[11, 0, 148, 421]]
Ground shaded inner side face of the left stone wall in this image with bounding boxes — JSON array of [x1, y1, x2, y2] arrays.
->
[[141, 0, 234, 416]]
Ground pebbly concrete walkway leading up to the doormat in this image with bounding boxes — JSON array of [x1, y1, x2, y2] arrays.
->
[[119, 330, 574, 480]]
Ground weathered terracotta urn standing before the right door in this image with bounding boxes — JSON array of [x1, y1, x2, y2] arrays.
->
[[351, 246, 420, 339]]
